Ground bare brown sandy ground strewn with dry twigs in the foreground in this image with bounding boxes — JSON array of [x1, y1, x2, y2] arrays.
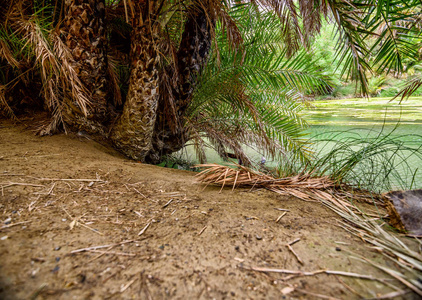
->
[[0, 121, 416, 299]]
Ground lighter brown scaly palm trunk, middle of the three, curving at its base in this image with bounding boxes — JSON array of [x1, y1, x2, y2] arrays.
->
[[111, 1, 160, 162]]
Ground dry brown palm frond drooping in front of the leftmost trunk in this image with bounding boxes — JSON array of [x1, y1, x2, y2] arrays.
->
[[0, 1, 90, 134]]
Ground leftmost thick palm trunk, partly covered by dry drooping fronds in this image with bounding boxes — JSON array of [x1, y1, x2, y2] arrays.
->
[[61, 0, 108, 132]]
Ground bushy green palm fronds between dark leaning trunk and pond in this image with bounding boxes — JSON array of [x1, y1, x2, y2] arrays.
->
[[189, 6, 329, 163]]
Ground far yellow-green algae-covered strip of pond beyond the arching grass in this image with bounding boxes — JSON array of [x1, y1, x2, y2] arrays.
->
[[302, 97, 422, 143]]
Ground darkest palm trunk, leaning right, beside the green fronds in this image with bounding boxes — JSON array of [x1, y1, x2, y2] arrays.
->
[[147, 5, 213, 163]]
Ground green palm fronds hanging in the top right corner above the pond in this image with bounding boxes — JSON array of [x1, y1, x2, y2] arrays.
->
[[329, 0, 421, 94]]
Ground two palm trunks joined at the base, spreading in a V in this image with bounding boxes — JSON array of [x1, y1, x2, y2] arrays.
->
[[111, 2, 218, 162]]
